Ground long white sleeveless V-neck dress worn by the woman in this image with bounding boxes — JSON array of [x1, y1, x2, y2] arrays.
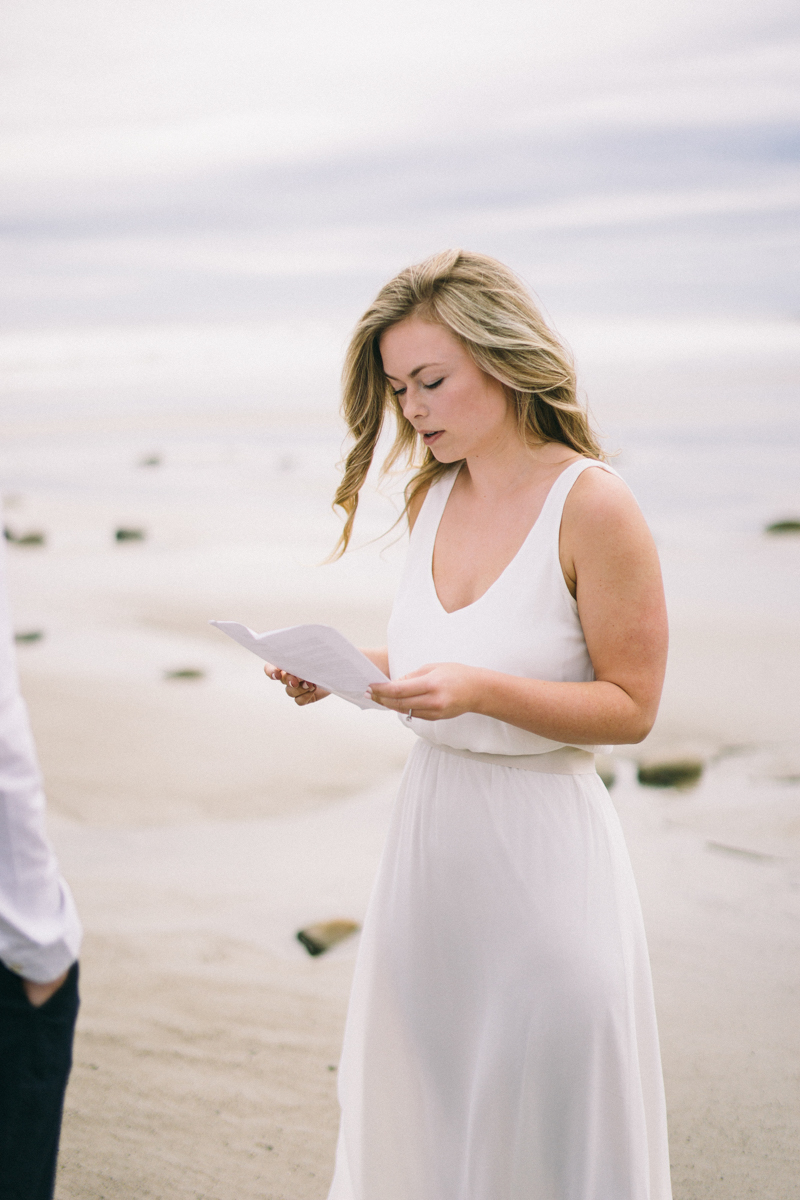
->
[[329, 458, 672, 1200]]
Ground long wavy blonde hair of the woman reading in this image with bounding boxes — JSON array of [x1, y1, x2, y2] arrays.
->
[[333, 250, 603, 557]]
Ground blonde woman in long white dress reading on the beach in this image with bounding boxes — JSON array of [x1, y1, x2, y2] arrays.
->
[[267, 251, 670, 1200]]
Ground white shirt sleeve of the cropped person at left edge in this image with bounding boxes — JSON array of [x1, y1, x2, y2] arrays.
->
[[0, 544, 82, 983]]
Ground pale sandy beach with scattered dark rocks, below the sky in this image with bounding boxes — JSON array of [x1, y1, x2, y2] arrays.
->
[[0, 319, 800, 1200]]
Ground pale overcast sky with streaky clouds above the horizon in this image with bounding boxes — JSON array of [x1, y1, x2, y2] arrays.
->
[[0, 0, 800, 350]]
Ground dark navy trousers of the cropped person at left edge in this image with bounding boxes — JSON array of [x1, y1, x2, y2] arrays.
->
[[0, 962, 79, 1200]]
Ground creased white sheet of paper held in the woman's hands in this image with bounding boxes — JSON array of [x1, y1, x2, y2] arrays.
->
[[211, 620, 387, 713]]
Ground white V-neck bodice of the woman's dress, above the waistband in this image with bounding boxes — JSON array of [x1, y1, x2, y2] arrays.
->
[[389, 458, 616, 755]]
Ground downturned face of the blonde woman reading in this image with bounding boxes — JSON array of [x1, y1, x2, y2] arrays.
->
[[380, 317, 517, 462]]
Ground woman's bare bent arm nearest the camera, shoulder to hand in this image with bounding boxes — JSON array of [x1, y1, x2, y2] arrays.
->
[[373, 470, 667, 745]]
